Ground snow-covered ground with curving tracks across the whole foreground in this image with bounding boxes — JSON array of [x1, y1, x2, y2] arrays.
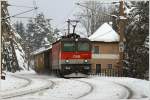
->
[[0, 72, 150, 100]]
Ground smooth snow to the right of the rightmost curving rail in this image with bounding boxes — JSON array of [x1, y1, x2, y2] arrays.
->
[[92, 77, 150, 100]]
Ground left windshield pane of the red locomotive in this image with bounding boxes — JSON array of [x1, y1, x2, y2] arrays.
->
[[62, 42, 75, 51]]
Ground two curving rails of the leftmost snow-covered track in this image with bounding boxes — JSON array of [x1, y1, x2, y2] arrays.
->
[[1, 76, 54, 99]]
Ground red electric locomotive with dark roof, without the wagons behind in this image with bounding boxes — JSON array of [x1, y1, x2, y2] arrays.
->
[[52, 34, 91, 76]]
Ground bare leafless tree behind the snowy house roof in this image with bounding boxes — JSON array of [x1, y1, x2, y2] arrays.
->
[[76, 1, 114, 36]]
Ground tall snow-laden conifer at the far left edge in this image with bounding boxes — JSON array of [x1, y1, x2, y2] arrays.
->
[[1, 1, 27, 72]]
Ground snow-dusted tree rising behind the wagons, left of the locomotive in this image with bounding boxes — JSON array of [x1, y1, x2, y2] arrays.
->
[[26, 14, 54, 51]]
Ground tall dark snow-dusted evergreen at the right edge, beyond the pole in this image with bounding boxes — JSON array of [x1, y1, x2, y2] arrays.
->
[[124, 1, 149, 78]]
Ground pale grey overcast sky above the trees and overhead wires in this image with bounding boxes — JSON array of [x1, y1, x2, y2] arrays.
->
[[9, 0, 80, 26]]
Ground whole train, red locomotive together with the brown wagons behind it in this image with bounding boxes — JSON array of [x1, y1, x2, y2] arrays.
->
[[34, 34, 92, 77]]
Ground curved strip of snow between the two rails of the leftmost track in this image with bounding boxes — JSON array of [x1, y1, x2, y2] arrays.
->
[[1, 76, 54, 99]]
